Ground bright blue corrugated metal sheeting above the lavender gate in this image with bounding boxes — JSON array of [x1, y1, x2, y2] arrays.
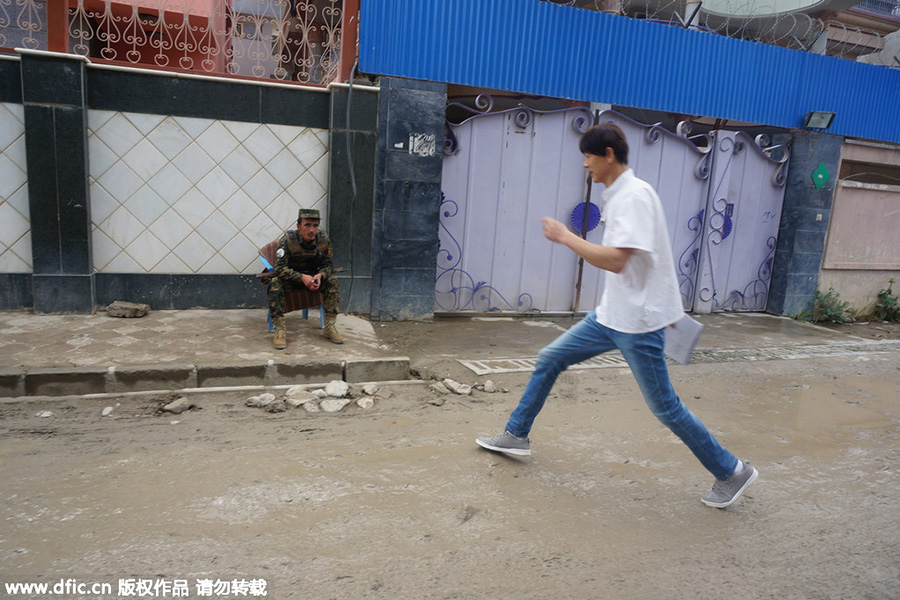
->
[[359, 0, 900, 143]]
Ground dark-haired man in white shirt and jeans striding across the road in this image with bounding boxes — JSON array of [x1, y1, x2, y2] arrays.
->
[[476, 123, 758, 508]]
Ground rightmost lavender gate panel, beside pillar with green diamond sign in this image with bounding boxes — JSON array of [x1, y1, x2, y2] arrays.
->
[[694, 131, 787, 312]]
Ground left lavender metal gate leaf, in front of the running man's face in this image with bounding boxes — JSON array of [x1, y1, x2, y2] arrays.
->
[[435, 108, 590, 312]]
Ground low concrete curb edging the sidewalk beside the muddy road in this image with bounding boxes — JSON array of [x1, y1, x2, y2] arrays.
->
[[0, 356, 409, 398]]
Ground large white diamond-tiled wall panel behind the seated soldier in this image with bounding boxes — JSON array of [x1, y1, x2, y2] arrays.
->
[[89, 110, 328, 274]]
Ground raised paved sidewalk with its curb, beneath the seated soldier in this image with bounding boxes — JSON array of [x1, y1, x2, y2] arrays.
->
[[0, 309, 409, 397]]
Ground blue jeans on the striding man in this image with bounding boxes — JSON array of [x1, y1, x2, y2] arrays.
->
[[506, 311, 738, 479]]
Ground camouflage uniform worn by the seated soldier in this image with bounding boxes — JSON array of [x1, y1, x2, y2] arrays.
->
[[268, 229, 341, 319]]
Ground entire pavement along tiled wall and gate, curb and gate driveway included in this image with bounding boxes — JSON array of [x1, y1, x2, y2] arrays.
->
[[0, 309, 896, 397]]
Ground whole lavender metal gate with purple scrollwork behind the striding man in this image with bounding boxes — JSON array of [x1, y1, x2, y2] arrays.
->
[[435, 105, 786, 312]]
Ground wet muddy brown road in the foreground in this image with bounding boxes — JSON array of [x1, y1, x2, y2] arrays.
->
[[0, 352, 900, 600]]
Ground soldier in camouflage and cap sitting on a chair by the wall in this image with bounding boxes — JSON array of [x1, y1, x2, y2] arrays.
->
[[268, 208, 344, 350]]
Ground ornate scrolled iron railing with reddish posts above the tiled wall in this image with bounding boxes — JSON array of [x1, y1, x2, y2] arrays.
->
[[0, 0, 359, 85]]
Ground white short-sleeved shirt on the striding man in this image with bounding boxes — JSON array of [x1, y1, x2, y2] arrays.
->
[[597, 169, 684, 333]]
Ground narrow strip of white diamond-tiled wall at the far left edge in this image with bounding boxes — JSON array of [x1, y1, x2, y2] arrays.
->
[[0, 102, 33, 273]]
